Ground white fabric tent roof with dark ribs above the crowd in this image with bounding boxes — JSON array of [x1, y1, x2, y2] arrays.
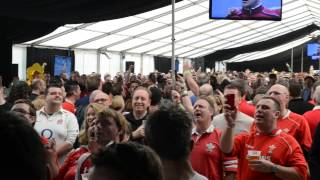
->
[[20, 0, 320, 61]]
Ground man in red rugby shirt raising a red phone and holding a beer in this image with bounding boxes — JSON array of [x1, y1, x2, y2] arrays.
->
[[220, 97, 307, 180]]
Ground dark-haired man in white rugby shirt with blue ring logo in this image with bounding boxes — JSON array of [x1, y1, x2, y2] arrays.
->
[[34, 84, 79, 163]]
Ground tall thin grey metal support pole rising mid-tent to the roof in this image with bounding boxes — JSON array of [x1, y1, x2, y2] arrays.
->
[[171, 0, 176, 87]]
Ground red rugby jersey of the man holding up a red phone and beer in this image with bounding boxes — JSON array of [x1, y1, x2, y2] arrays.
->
[[227, 129, 307, 180]]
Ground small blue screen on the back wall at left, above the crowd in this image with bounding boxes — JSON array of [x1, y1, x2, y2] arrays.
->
[[54, 55, 72, 78]]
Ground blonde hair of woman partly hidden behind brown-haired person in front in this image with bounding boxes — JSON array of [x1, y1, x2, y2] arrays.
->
[[79, 103, 106, 145]]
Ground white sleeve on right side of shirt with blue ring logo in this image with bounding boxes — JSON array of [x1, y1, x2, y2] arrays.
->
[[66, 113, 79, 145]]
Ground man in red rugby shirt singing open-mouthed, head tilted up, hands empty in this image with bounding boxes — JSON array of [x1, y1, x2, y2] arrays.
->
[[190, 97, 224, 180]]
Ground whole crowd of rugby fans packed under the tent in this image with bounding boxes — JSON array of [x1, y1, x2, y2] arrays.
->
[[0, 67, 320, 180]]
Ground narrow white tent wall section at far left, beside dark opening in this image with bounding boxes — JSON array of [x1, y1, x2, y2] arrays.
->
[[12, 46, 27, 80]]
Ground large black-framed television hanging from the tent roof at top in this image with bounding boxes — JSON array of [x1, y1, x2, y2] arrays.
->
[[209, 0, 282, 21]]
